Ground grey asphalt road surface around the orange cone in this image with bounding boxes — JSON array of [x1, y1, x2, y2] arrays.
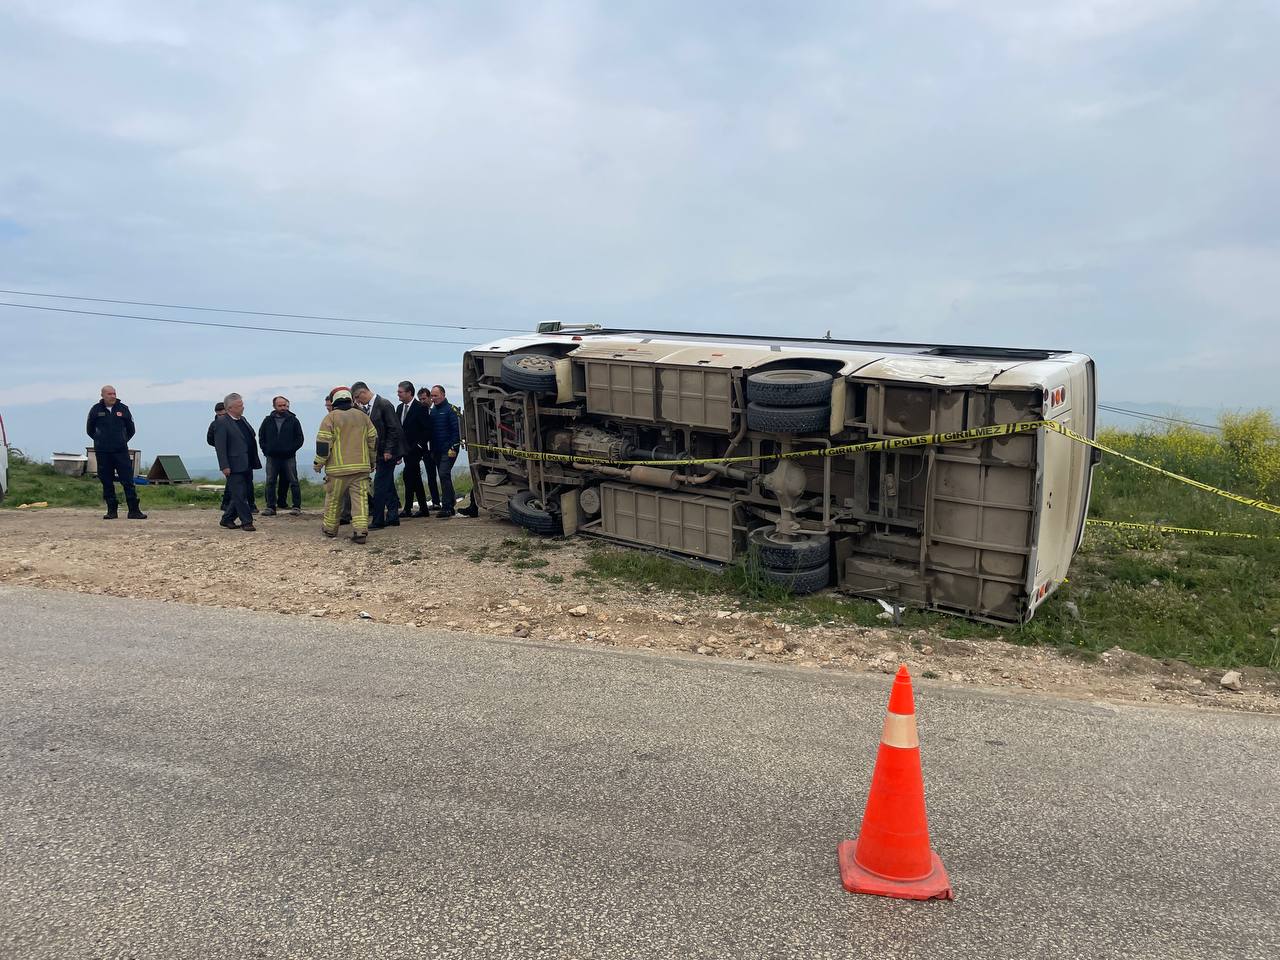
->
[[0, 588, 1280, 960]]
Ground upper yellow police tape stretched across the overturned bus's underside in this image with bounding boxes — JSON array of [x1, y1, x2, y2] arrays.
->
[[465, 420, 1280, 529]]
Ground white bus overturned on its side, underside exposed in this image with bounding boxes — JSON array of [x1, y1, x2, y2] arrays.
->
[[462, 323, 1097, 623]]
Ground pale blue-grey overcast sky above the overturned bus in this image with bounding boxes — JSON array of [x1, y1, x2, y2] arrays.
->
[[0, 0, 1280, 448]]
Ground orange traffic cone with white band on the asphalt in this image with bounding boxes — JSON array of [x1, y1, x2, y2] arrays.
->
[[837, 667, 954, 900]]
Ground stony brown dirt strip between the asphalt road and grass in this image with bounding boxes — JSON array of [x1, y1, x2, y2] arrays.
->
[[0, 508, 1280, 713]]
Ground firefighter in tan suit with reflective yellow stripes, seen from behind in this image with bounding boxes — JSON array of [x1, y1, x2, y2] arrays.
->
[[311, 387, 376, 543]]
